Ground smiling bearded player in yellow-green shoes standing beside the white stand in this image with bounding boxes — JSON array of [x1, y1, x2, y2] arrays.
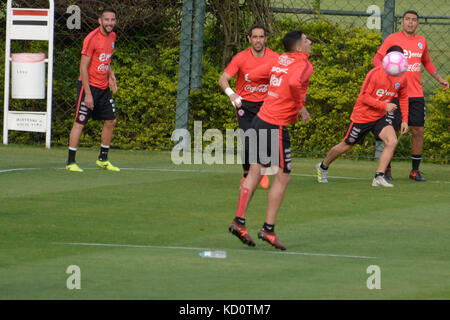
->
[[66, 9, 120, 172]]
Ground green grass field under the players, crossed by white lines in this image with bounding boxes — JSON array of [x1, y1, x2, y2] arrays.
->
[[0, 145, 450, 300]]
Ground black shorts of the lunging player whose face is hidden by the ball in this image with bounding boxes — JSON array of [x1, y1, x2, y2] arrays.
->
[[343, 114, 393, 145]]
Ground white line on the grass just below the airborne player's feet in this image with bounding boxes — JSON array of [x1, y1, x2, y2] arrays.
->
[[54, 242, 378, 259]]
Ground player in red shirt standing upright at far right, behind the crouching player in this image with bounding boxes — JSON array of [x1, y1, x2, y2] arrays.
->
[[373, 11, 449, 181]]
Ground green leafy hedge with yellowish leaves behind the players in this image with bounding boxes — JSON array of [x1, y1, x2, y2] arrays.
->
[[0, 20, 450, 160]]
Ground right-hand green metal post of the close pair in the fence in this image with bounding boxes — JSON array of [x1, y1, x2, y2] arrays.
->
[[191, 0, 206, 91]]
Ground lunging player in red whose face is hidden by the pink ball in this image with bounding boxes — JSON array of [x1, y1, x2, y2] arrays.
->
[[316, 46, 408, 187]]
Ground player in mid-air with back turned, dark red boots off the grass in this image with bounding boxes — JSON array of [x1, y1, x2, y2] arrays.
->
[[229, 31, 313, 250]]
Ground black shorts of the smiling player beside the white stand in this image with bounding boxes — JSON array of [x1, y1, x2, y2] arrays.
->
[[75, 81, 116, 125]]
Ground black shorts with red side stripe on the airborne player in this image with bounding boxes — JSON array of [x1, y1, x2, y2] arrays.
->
[[249, 116, 292, 173]]
